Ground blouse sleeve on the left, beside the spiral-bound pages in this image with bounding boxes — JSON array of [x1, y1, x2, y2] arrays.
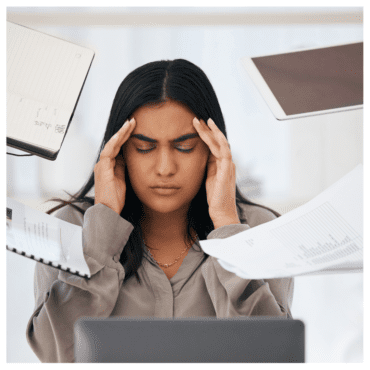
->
[[26, 204, 134, 362]]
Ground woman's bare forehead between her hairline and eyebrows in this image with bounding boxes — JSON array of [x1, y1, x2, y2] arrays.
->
[[132, 101, 196, 140]]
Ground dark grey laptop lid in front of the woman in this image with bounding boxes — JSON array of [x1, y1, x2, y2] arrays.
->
[[74, 316, 305, 363]]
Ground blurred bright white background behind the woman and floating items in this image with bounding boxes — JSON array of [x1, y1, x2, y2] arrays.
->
[[6, 7, 363, 362]]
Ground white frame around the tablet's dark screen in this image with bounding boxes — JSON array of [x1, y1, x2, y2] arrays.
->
[[241, 40, 363, 121]]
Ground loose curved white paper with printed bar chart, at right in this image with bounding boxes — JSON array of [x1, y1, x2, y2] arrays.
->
[[200, 164, 363, 279]]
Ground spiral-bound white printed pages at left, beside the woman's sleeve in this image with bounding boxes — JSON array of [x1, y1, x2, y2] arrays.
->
[[6, 197, 91, 279]]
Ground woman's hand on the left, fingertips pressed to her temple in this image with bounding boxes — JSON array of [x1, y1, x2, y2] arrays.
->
[[94, 118, 136, 215]]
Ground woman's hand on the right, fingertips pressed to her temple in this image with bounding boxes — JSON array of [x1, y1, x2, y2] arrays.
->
[[193, 118, 240, 229]]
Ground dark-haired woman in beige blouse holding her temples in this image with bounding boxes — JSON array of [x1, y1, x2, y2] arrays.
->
[[27, 59, 293, 362]]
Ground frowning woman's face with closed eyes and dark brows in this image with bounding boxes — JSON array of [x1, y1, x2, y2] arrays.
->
[[123, 101, 210, 213]]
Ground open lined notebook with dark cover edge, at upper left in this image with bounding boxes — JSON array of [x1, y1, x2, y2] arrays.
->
[[6, 22, 95, 160]]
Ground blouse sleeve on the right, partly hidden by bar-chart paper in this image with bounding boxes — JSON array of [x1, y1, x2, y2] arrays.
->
[[202, 207, 294, 319]]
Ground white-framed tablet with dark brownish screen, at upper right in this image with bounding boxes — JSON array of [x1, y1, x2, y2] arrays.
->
[[241, 42, 363, 120]]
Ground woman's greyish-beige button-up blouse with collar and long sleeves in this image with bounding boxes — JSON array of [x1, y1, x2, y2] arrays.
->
[[26, 203, 294, 362]]
